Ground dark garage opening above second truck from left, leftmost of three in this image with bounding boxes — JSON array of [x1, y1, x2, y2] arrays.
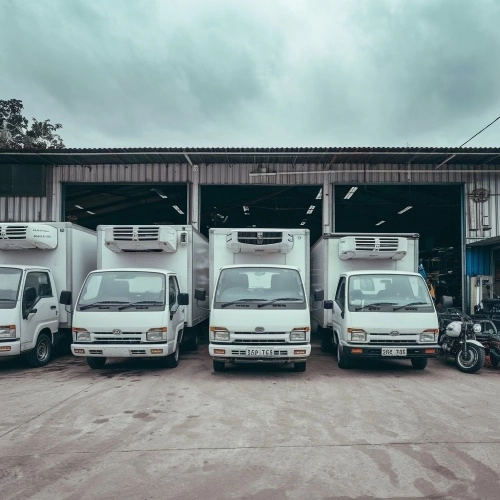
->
[[63, 183, 188, 229]]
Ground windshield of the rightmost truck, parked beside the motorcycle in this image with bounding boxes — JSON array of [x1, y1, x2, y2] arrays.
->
[[347, 274, 434, 312]]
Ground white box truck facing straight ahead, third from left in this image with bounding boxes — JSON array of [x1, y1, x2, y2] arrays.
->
[[195, 228, 320, 371]]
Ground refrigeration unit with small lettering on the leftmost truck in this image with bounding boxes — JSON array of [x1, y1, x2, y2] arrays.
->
[[0, 223, 57, 250]]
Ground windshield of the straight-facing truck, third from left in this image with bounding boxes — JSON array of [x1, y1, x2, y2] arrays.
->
[[214, 267, 306, 309]]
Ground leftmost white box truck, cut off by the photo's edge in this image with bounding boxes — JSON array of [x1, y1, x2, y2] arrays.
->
[[0, 222, 97, 367]]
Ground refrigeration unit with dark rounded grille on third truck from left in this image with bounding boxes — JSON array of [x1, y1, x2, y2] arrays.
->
[[226, 229, 293, 253]]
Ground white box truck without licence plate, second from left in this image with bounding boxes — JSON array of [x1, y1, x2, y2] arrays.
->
[[71, 225, 208, 368]]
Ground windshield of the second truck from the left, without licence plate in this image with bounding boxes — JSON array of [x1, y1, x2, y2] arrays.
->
[[77, 271, 166, 311]]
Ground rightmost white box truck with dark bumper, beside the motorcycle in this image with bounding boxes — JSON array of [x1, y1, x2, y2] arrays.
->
[[311, 233, 439, 369]]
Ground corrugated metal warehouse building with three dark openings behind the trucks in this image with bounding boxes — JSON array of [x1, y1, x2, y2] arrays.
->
[[0, 148, 500, 311]]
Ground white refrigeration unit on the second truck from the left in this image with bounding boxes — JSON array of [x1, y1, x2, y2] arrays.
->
[[104, 226, 187, 253]]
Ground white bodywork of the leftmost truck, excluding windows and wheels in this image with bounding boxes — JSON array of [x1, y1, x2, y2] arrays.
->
[[0, 222, 97, 356]]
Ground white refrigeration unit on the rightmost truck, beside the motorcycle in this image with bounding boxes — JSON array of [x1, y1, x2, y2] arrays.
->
[[339, 235, 408, 260]]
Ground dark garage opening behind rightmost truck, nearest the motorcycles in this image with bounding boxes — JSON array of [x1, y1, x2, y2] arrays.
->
[[334, 184, 463, 307]]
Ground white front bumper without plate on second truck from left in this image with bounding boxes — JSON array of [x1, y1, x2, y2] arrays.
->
[[71, 341, 175, 358]]
